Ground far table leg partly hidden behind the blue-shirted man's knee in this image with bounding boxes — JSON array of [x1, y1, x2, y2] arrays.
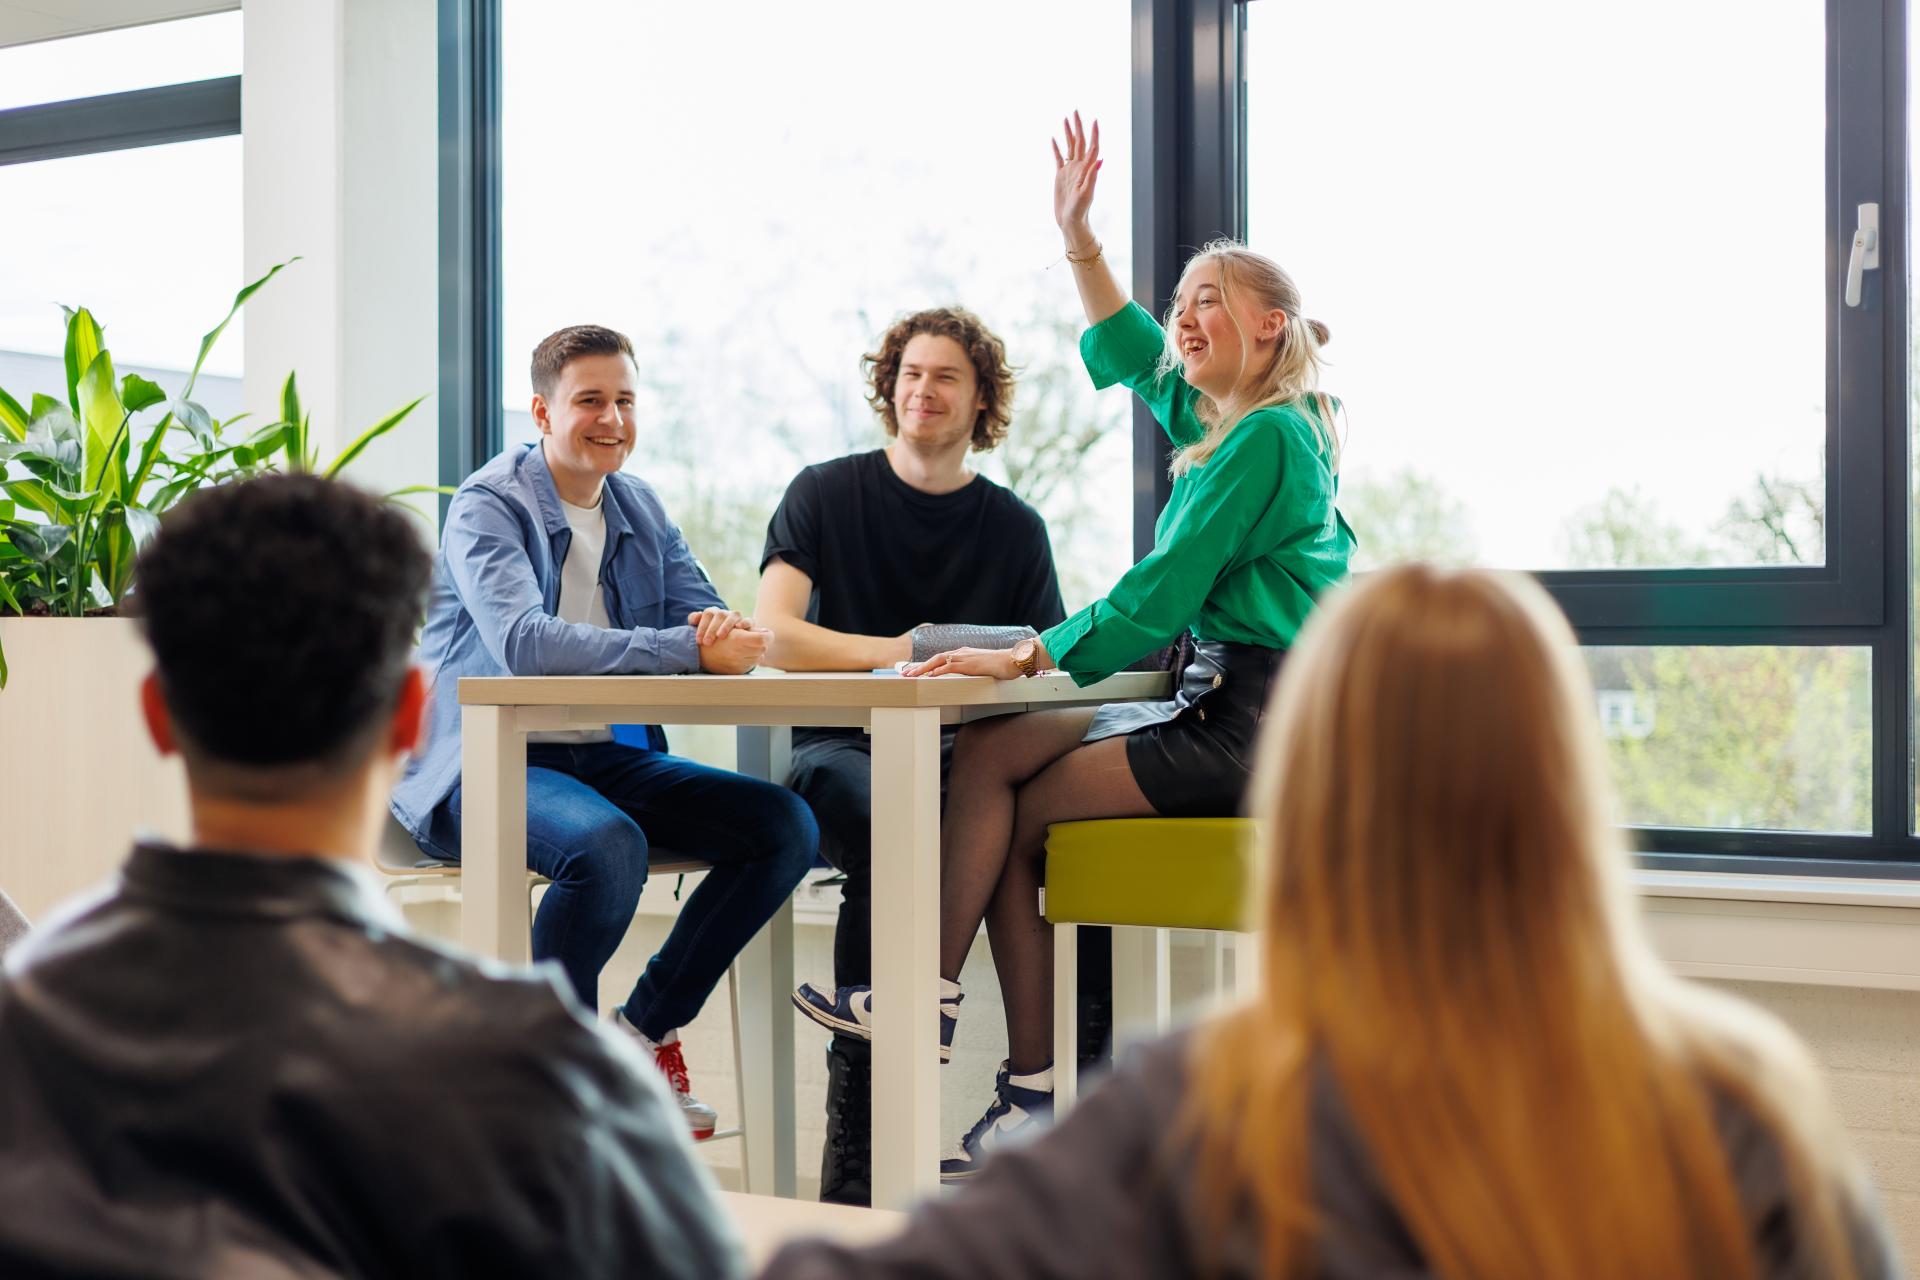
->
[[733, 725, 797, 1197]]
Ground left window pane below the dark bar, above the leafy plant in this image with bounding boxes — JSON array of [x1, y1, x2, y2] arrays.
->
[[0, 138, 244, 416]]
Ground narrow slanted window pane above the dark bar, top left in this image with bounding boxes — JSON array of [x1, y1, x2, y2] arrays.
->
[[0, 8, 240, 111]]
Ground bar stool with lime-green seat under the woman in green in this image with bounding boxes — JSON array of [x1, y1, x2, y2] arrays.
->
[[1041, 818, 1258, 1111]]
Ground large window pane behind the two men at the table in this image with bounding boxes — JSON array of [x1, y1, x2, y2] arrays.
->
[[501, 0, 1133, 621]]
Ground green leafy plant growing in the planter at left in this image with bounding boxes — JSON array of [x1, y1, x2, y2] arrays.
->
[[0, 259, 438, 687]]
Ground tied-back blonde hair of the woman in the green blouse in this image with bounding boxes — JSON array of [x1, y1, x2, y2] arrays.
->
[[1160, 240, 1340, 476]]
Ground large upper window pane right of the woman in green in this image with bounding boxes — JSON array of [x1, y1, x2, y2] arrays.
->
[[1248, 0, 1828, 568]]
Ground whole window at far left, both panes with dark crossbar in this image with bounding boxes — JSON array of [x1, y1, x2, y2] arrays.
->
[[0, 13, 244, 416]]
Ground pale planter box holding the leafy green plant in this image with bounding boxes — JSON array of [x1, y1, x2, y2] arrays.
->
[[0, 618, 186, 919]]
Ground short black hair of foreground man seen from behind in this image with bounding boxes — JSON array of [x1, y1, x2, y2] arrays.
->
[[132, 476, 432, 794]]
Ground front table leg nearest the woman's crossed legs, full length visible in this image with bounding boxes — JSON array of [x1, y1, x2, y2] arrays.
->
[[874, 706, 941, 1209]]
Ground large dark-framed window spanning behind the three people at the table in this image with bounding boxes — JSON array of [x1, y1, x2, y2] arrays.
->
[[444, 0, 1920, 873]]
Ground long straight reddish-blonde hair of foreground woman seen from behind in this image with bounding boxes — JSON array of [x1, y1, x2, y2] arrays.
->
[[1185, 566, 1855, 1280]]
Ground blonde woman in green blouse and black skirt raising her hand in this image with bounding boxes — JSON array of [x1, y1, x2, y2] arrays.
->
[[795, 113, 1354, 1180]]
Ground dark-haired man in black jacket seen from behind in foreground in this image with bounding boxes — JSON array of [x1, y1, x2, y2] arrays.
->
[[0, 476, 745, 1280]]
